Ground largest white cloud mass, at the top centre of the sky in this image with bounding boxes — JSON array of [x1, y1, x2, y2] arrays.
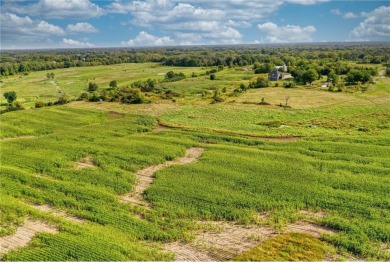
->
[[108, 0, 247, 45]]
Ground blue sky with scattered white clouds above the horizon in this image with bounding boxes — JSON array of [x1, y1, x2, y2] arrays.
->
[[0, 0, 390, 49]]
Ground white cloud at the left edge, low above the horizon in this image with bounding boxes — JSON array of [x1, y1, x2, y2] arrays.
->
[[0, 13, 65, 46]]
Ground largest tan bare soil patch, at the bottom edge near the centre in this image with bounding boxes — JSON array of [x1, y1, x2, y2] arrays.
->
[[165, 222, 276, 261]]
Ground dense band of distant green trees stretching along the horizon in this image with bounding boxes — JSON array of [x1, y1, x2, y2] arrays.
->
[[0, 43, 390, 76]]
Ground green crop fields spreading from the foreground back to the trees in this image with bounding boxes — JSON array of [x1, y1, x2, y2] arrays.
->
[[0, 63, 390, 261]]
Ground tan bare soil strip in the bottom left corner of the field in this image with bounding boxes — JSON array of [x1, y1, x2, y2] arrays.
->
[[0, 219, 58, 255]]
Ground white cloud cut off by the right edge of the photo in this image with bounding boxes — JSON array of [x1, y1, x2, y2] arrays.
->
[[350, 6, 390, 41]]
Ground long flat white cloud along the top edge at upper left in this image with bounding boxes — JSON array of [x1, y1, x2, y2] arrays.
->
[[4, 0, 105, 19]]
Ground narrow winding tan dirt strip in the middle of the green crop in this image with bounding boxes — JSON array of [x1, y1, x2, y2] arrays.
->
[[121, 147, 204, 206]]
